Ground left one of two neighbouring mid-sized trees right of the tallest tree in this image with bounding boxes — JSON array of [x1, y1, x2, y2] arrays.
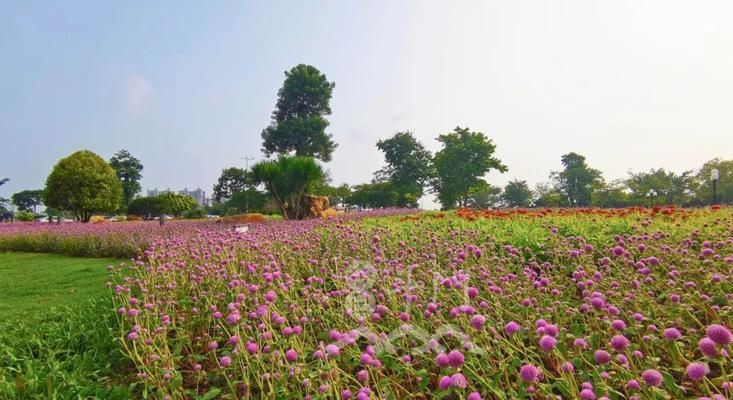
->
[[376, 132, 433, 207]]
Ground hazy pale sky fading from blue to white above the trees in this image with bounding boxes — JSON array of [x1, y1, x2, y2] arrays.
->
[[0, 0, 733, 209]]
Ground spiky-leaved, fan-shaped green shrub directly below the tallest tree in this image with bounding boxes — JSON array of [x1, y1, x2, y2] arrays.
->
[[252, 156, 326, 219]]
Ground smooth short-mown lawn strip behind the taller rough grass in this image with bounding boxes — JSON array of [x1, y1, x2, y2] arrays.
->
[[0, 253, 120, 320]]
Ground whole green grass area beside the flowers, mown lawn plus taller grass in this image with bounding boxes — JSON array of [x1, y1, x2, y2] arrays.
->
[[0, 253, 133, 399]]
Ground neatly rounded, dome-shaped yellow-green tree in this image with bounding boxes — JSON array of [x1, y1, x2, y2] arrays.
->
[[43, 150, 122, 222]]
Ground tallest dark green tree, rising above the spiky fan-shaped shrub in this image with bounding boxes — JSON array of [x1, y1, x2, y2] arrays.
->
[[262, 64, 336, 161]]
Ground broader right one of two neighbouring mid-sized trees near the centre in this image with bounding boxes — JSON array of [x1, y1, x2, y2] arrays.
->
[[433, 127, 507, 209]]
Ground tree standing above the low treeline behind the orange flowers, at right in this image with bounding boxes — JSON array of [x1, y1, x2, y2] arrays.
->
[[550, 153, 602, 207]]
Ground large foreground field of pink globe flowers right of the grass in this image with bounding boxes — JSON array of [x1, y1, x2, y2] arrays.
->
[[109, 208, 733, 400]]
